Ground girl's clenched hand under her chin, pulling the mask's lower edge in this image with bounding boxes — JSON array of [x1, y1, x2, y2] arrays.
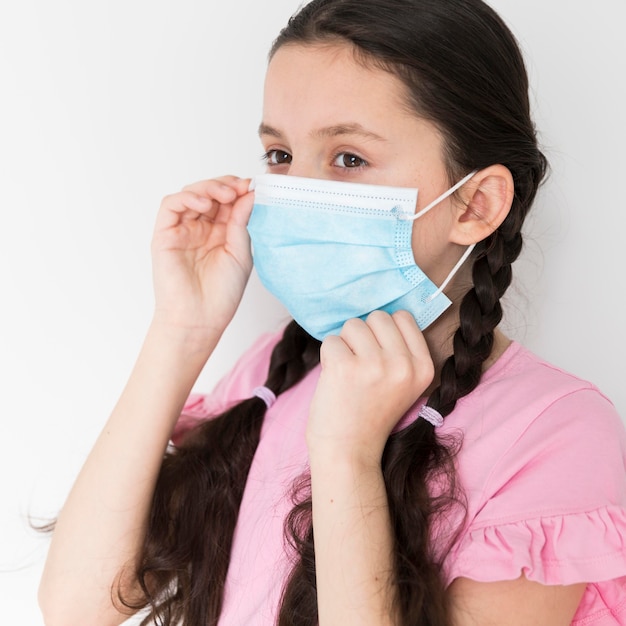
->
[[307, 311, 434, 463]]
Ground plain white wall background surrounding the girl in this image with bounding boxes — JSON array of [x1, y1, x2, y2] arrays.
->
[[0, 0, 626, 626]]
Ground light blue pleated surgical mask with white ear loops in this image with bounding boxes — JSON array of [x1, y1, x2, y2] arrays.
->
[[248, 172, 474, 340]]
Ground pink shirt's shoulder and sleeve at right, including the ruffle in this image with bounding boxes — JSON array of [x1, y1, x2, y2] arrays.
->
[[449, 344, 626, 584]]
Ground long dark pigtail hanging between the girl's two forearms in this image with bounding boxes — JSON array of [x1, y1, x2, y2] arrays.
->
[[118, 322, 319, 626]]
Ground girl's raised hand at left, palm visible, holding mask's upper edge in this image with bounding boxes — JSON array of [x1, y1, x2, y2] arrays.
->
[[152, 176, 253, 342]]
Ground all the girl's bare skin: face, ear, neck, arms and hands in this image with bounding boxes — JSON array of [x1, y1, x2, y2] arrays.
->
[[39, 45, 584, 626]]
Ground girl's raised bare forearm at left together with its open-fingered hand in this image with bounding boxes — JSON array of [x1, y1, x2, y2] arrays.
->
[[39, 177, 252, 626]]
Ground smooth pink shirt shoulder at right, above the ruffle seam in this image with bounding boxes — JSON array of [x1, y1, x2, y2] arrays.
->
[[447, 344, 626, 519]]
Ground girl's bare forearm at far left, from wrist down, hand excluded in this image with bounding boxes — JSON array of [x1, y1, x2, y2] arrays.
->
[[39, 324, 215, 626]]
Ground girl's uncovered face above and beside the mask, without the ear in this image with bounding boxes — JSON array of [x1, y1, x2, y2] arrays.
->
[[259, 44, 462, 284]]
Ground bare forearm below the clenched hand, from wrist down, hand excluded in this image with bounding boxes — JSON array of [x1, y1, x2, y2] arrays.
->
[[311, 446, 398, 626]]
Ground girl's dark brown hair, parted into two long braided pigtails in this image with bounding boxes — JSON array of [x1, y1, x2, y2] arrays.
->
[[120, 0, 547, 626]]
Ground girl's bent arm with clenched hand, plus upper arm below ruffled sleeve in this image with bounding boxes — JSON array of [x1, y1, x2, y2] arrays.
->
[[307, 312, 585, 626]]
